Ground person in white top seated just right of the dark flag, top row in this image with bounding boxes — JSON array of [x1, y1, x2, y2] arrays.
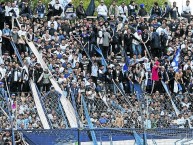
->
[[97, 0, 108, 21]]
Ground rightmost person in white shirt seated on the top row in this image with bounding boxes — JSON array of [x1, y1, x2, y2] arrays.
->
[[181, 0, 192, 23]]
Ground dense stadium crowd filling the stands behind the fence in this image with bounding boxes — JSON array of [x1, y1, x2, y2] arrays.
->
[[0, 0, 193, 133]]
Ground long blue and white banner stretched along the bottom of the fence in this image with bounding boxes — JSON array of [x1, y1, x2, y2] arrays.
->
[[19, 128, 193, 145]]
